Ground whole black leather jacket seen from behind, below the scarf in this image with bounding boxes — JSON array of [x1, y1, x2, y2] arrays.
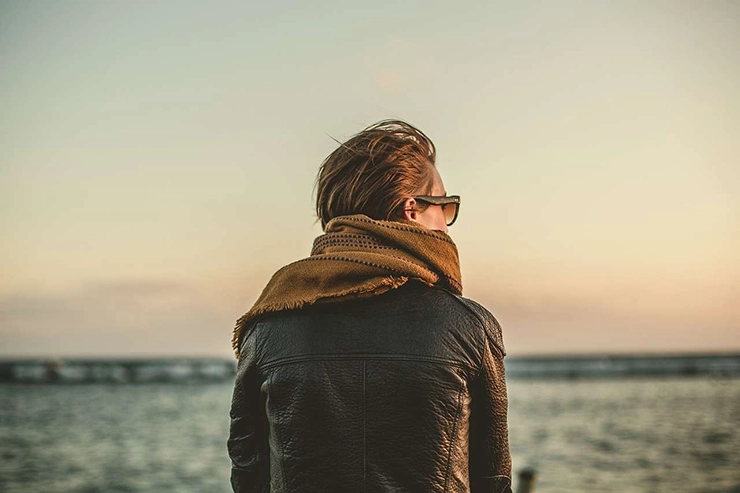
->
[[228, 281, 511, 493]]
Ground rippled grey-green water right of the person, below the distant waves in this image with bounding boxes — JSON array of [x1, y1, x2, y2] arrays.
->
[[509, 379, 740, 493]]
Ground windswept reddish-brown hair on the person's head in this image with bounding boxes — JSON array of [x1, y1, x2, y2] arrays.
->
[[316, 120, 436, 229]]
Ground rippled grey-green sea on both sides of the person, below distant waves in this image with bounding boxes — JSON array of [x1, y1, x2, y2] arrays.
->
[[0, 378, 740, 493]]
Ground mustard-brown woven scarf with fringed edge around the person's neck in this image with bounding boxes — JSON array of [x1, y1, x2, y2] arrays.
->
[[231, 214, 462, 359]]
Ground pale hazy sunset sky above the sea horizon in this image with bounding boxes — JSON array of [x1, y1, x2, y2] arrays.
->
[[0, 0, 740, 358]]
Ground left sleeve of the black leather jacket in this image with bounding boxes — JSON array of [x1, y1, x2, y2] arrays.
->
[[227, 324, 270, 493]]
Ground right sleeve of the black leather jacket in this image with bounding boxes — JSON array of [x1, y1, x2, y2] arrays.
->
[[470, 309, 511, 493]]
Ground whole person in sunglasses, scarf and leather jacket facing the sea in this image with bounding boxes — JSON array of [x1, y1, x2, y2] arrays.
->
[[227, 120, 511, 493]]
